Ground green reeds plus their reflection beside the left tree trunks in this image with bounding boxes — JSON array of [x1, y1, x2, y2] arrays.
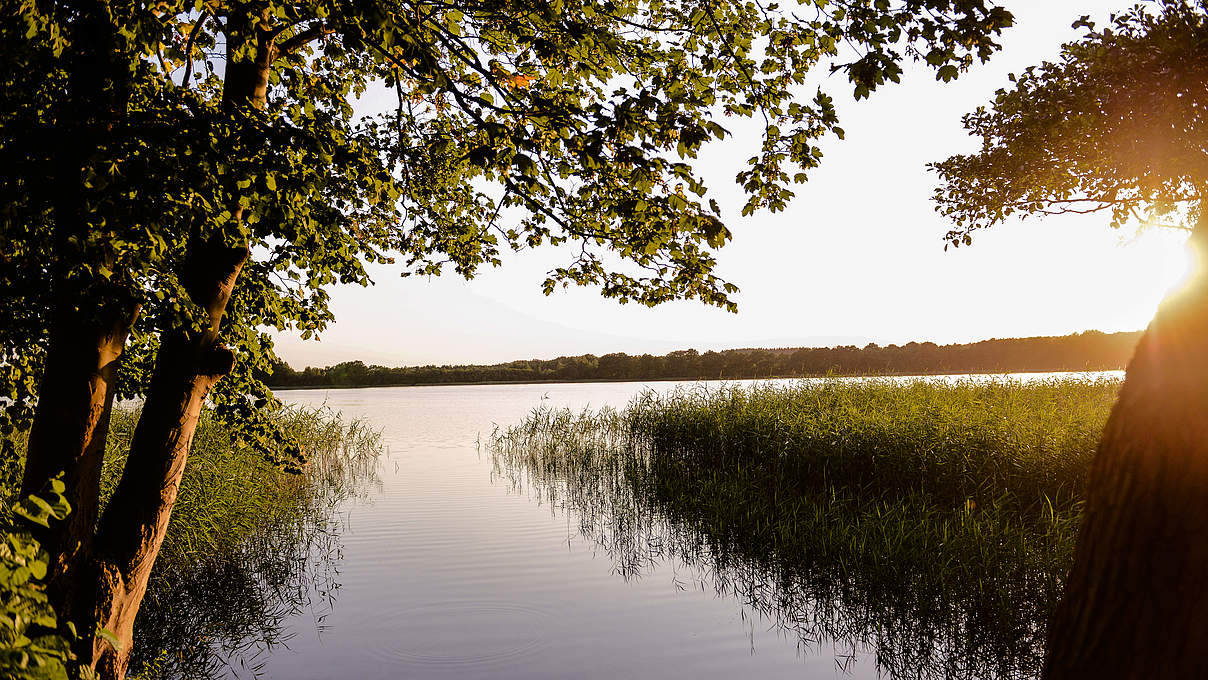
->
[[124, 409, 381, 680]]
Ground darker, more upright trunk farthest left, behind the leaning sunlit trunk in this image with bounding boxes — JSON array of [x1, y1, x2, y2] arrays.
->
[[21, 0, 139, 651]]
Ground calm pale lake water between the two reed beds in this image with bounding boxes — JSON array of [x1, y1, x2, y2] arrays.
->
[[183, 372, 1121, 679]]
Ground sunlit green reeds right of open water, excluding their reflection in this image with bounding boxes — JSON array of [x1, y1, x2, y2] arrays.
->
[[627, 380, 1117, 510]]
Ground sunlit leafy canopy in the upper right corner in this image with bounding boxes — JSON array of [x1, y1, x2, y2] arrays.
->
[[931, 0, 1208, 245]]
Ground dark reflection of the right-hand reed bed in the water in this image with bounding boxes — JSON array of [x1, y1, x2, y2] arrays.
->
[[492, 411, 1068, 679]]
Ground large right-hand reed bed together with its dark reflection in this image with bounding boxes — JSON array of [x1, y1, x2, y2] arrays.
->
[[492, 380, 1119, 678]]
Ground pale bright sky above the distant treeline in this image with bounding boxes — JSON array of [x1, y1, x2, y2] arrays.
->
[[277, 0, 1187, 368]]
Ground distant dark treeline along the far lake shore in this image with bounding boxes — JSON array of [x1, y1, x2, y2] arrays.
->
[[268, 331, 1140, 388]]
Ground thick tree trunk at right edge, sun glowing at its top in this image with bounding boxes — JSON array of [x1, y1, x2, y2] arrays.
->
[[1044, 221, 1208, 680]]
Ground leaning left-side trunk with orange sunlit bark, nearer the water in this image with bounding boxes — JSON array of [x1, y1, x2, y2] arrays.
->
[[87, 12, 277, 680]]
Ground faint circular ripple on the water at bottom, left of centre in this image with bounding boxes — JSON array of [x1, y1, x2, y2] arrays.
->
[[366, 600, 550, 672]]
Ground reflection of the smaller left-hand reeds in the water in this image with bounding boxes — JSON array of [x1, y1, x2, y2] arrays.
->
[[130, 439, 381, 680]]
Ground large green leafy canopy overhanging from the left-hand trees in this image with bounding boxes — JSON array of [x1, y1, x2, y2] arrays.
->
[[0, 0, 1011, 456]]
